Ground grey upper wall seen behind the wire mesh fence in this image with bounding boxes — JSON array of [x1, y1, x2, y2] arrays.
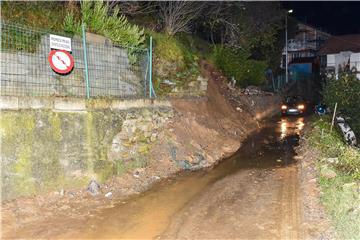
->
[[0, 33, 147, 97]]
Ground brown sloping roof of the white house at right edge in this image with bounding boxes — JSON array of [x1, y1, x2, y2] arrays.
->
[[319, 34, 360, 55]]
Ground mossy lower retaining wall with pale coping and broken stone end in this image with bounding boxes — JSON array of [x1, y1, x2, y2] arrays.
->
[[0, 97, 174, 200]]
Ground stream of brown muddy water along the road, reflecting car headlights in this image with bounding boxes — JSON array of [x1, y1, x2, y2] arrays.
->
[[64, 117, 305, 239]]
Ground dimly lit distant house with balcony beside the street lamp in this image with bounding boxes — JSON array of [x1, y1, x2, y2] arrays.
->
[[281, 23, 331, 69]]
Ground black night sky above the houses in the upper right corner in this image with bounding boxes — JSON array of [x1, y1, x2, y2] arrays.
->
[[282, 1, 360, 35]]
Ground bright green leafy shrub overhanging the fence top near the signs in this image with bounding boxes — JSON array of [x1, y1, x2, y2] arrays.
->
[[63, 1, 145, 48]]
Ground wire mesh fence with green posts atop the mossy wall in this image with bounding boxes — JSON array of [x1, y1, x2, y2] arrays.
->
[[0, 21, 151, 98]]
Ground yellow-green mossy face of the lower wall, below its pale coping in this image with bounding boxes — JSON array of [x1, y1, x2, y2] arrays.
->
[[0, 106, 172, 200]]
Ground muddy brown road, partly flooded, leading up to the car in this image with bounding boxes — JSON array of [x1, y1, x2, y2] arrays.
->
[[7, 117, 304, 239]]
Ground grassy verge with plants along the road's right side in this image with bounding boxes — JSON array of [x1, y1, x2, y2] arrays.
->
[[309, 119, 360, 239]]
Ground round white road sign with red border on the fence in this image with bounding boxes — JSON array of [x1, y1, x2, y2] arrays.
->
[[48, 50, 74, 74]]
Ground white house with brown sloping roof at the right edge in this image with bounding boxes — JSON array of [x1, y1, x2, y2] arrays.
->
[[319, 34, 360, 79]]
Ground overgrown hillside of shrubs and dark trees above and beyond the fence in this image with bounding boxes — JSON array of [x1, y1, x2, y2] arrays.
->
[[2, 1, 282, 96]]
